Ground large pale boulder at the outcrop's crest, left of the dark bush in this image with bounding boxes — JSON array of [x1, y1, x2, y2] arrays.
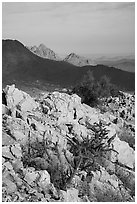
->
[[42, 92, 83, 123]]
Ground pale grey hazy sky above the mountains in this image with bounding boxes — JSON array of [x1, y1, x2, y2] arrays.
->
[[2, 2, 135, 55]]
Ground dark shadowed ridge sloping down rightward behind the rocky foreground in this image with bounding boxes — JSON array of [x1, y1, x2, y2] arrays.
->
[[2, 40, 135, 91]]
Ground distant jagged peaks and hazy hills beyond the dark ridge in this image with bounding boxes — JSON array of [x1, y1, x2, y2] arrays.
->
[[27, 44, 135, 72]]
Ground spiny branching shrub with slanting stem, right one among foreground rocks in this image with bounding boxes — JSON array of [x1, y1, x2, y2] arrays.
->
[[66, 122, 118, 189]]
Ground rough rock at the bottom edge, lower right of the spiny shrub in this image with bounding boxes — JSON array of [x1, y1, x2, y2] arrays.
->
[[89, 168, 132, 202]]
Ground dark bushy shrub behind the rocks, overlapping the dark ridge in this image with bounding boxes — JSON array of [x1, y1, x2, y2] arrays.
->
[[72, 71, 119, 107]]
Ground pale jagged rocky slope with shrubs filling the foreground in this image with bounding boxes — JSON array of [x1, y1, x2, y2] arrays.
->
[[2, 85, 135, 202]]
